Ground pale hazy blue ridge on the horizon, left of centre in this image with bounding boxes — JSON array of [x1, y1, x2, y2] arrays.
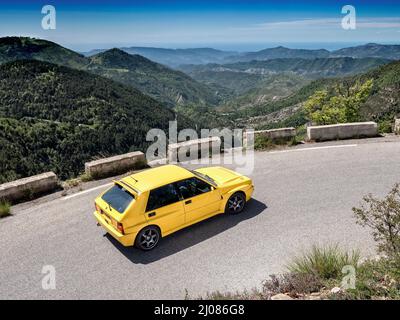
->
[[84, 47, 237, 67]]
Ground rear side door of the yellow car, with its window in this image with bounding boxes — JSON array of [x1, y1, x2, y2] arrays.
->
[[145, 183, 185, 235]]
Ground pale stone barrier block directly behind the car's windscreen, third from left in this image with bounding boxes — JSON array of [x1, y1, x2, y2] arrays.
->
[[168, 137, 221, 163]]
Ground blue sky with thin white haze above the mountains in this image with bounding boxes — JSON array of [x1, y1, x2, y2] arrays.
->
[[0, 0, 400, 51]]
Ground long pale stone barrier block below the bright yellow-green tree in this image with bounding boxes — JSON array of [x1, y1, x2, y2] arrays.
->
[[307, 122, 378, 141]]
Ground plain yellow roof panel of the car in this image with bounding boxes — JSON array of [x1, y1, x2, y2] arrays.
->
[[120, 165, 194, 192]]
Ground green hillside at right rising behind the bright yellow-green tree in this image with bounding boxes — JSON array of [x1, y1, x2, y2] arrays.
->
[[236, 61, 400, 128]]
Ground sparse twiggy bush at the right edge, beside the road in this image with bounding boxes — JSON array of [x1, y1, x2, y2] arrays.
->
[[353, 184, 400, 262]]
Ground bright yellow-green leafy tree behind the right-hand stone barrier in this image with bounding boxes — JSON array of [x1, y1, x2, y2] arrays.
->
[[304, 79, 373, 125]]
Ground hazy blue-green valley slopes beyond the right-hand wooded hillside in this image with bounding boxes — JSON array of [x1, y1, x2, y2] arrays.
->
[[181, 58, 391, 111]]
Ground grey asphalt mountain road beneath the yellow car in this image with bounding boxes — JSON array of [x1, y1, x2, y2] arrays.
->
[[0, 139, 400, 299]]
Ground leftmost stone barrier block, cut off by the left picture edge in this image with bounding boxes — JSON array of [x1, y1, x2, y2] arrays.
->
[[0, 172, 58, 203]]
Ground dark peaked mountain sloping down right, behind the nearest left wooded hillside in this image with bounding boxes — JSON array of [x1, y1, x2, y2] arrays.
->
[[86, 49, 219, 107]]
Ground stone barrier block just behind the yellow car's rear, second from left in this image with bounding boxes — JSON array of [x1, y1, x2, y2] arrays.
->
[[85, 151, 146, 179]]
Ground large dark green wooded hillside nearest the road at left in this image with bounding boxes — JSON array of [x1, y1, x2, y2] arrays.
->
[[0, 60, 186, 183]]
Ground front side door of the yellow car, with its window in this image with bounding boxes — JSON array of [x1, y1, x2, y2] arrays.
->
[[176, 177, 221, 224]]
